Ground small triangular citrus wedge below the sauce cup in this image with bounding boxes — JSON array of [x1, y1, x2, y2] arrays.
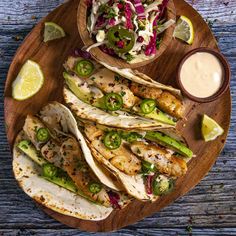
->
[[202, 115, 224, 142]]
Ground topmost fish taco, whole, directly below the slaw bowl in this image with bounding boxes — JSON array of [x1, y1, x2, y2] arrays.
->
[[63, 56, 185, 129]]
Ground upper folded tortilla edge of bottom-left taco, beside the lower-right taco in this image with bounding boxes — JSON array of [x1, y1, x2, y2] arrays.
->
[[40, 102, 122, 191]]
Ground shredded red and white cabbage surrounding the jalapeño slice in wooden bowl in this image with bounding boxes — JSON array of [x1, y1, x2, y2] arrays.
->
[[87, 0, 171, 61]]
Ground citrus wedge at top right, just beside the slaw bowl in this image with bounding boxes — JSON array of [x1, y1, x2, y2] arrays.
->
[[174, 16, 194, 44]]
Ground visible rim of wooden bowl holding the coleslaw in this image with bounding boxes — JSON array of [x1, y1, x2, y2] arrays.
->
[[77, 0, 176, 68]]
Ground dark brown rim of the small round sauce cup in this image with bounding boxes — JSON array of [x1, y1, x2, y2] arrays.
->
[[176, 47, 231, 103]]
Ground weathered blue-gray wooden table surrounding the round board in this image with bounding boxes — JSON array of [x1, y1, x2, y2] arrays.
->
[[0, 0, 236, 236]]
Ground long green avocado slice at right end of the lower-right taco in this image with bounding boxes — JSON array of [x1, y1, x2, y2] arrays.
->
[[145, 131, 193, 158]]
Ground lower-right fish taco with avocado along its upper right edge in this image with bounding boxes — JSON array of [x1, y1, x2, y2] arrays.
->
[[73, 120, 193, 201]]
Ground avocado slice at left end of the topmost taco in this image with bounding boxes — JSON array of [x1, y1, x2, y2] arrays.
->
[[63, 72, 105, 109]]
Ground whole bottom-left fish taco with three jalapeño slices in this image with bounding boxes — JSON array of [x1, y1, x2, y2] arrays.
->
[[13, 102, 131, 220]]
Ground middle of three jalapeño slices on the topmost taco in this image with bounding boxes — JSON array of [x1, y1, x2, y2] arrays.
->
[[104, 93, 123, 111]]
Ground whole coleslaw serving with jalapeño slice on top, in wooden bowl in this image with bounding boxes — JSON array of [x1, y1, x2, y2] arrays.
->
[[87, 0, 175, 63]]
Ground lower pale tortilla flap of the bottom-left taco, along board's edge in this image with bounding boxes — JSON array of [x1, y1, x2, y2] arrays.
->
[[13, 132, 113, 221]]
